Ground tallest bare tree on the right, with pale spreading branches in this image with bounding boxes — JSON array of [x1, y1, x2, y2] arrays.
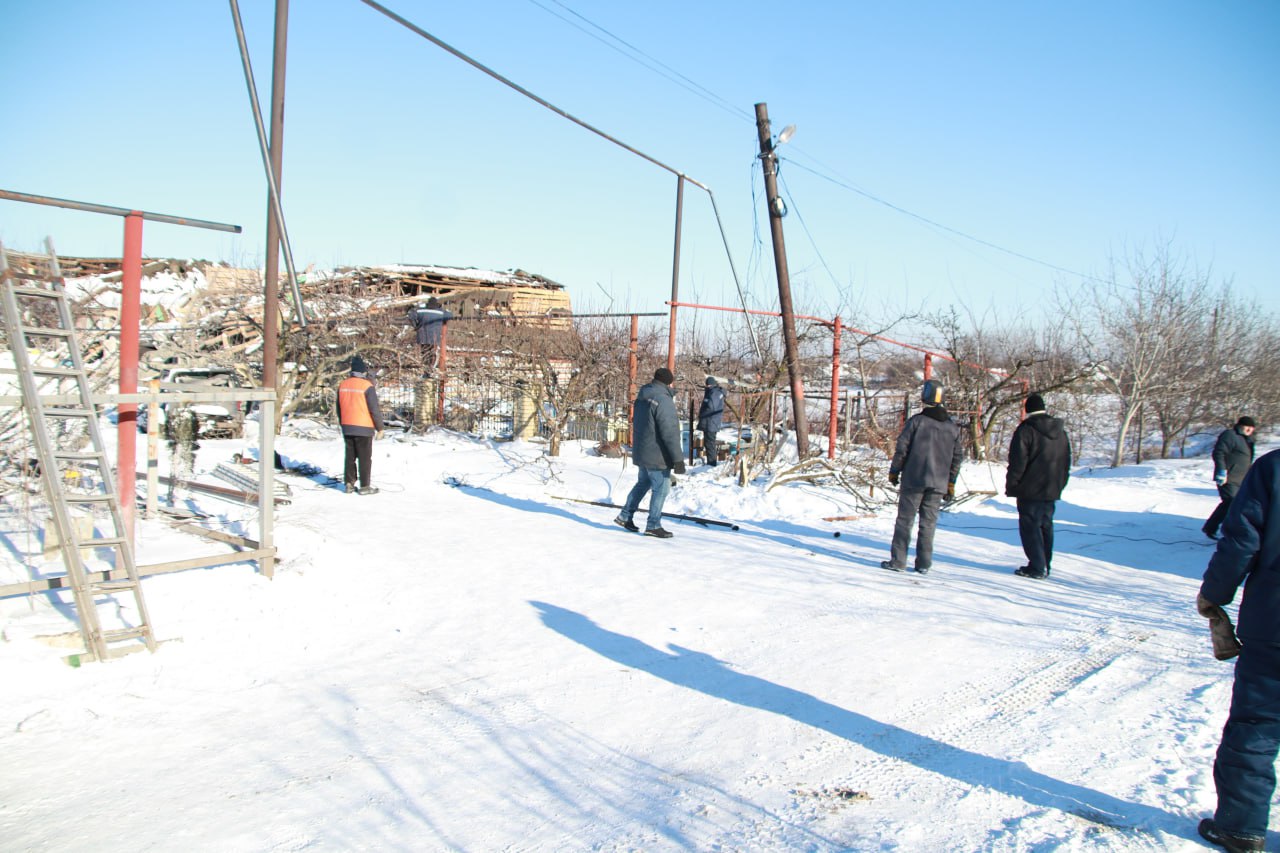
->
[[1064, 243, 1212, 467]]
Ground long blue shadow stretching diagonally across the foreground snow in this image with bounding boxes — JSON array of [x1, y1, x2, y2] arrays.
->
[[530, 601, 1185, 835]]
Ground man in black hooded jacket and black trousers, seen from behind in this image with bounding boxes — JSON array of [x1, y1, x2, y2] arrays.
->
[[1005, 394, 1071, 578]]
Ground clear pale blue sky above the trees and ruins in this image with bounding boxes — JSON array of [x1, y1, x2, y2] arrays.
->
[[0, 0, 1280, 321]]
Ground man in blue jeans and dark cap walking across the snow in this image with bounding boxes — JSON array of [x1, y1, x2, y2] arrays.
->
[[613, 368, 685, 539]]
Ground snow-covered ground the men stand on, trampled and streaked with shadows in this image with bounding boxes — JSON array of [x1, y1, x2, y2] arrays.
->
[[0, 428, 1276, 852]]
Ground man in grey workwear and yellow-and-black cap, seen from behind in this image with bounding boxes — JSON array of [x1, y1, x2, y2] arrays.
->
[[881, 379, 964, 575]]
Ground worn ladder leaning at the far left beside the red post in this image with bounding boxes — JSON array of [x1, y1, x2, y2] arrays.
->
[[0, 241, 156, 661]]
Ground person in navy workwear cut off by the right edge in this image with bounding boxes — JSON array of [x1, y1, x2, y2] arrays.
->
[[1196, 451, 1280, 850]]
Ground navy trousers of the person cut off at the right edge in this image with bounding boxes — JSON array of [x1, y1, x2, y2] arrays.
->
[[1213, 642, 1280, 838]]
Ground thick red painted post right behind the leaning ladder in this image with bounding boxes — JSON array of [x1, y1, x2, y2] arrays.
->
[[115, 210, 142, 542]]
